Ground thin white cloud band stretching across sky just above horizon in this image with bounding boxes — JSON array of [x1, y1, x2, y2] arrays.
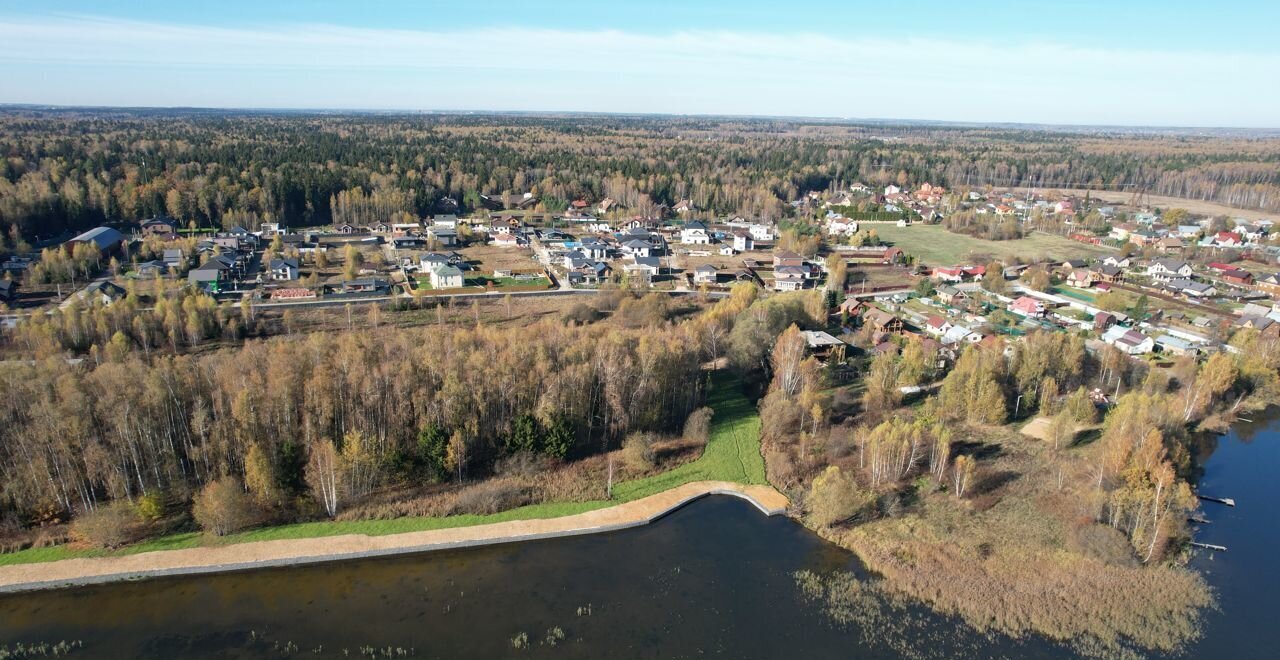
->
[[0, 15, 1280, 125]]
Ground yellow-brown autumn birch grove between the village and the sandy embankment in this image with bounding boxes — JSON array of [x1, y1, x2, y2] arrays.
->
[[0, 315, 704, 519]]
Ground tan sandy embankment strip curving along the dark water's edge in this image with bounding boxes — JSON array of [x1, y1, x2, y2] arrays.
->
[[0, 481, 788, 593]]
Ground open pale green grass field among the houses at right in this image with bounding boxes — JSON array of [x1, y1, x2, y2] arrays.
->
[[874, 225, 1114, 266]]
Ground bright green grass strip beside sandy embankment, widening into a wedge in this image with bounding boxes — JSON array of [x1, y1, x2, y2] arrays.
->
[[0, 372, 767, 565]]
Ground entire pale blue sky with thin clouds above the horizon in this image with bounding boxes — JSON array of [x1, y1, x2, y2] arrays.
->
[[0, 0, 1280, 128]]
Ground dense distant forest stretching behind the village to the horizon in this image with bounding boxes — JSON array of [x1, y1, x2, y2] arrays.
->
[[0, 110, 1280, 247]]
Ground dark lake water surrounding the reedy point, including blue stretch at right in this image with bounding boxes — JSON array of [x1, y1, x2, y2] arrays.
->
[[0, 416, 1280, 659]]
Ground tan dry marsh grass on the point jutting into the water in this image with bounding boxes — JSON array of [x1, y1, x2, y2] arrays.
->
[[822, 430, 1213, 654]]
